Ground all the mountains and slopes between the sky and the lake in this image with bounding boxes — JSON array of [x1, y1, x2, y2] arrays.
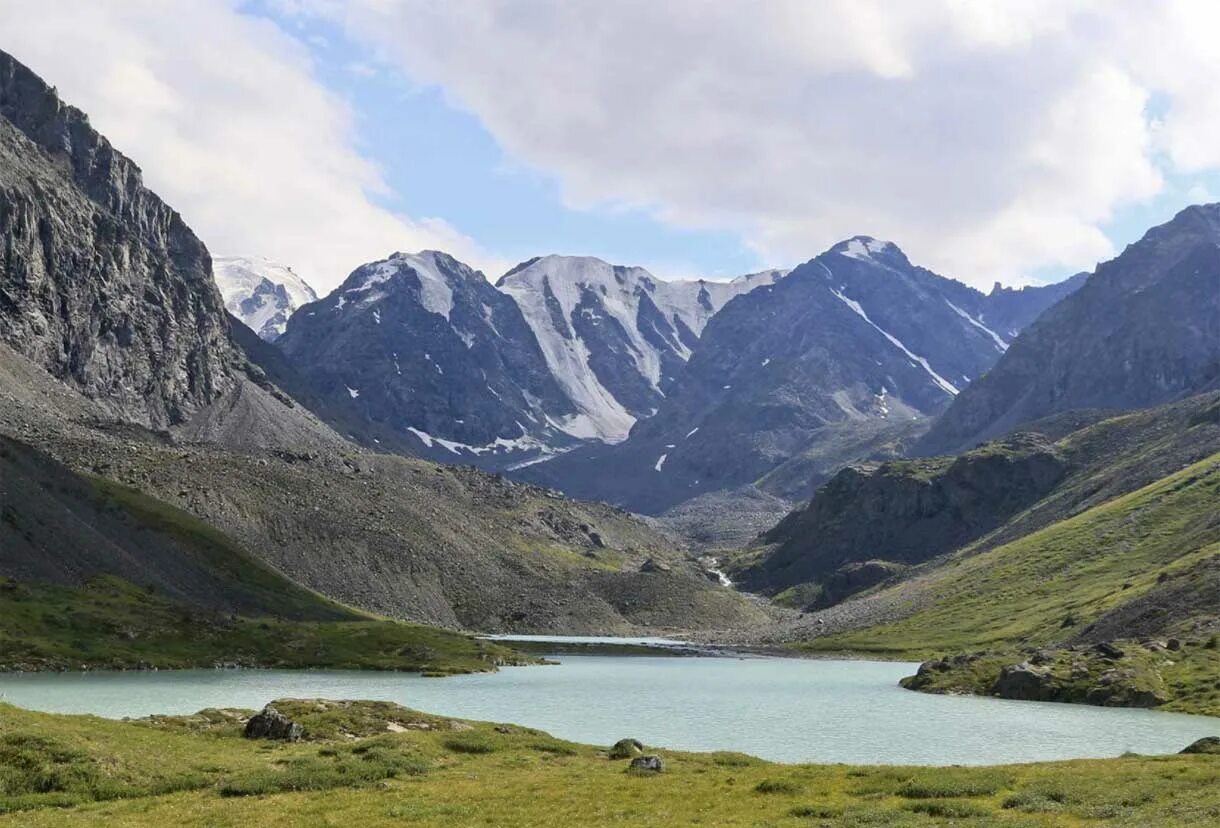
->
[[0, 40, 1220, 707]]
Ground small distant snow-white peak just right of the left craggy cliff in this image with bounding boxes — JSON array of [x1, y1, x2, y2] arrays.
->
[[212, 256, 317, 341]]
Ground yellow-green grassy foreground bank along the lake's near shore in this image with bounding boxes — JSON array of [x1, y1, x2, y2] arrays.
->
[[0, 701, 1220, 827]]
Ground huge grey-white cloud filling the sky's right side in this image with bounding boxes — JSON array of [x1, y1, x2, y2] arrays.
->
[[292, 0, 1220, 285]]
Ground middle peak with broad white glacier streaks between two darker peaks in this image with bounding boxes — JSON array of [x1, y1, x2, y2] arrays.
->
[[497, 256, 784, 441]]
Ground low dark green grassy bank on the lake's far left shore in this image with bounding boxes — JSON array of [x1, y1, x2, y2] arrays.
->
[[0, 576, 529, 674]]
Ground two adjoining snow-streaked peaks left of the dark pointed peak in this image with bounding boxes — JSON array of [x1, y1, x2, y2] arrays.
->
[[276, 251, 782, 468]]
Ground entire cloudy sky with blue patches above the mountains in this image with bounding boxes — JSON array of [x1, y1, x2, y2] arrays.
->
[[0, 0, 1220, 293]]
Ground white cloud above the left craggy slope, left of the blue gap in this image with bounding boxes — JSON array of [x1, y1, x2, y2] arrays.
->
[[0, 0, 503, 291]]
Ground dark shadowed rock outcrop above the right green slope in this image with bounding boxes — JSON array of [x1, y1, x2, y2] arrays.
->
[[737, 434, 1066, 606]]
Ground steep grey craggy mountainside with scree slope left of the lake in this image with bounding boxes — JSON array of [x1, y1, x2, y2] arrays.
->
[[0, 52, 760, 632]]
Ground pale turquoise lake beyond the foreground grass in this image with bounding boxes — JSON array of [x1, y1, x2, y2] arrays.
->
[[0, 656, 1220, 765]]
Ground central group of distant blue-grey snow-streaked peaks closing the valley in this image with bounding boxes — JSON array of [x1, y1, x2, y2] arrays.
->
[[219, 237, 1083, 524]]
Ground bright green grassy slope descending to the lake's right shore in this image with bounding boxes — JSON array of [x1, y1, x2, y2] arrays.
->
[[808, 454, 1220, 655]]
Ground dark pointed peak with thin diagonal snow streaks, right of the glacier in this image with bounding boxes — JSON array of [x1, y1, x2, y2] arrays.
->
[[521, 237, 1069, 515]]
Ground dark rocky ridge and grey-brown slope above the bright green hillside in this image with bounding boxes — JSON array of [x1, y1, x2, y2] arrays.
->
[[726, 394, 1220, 609]]
